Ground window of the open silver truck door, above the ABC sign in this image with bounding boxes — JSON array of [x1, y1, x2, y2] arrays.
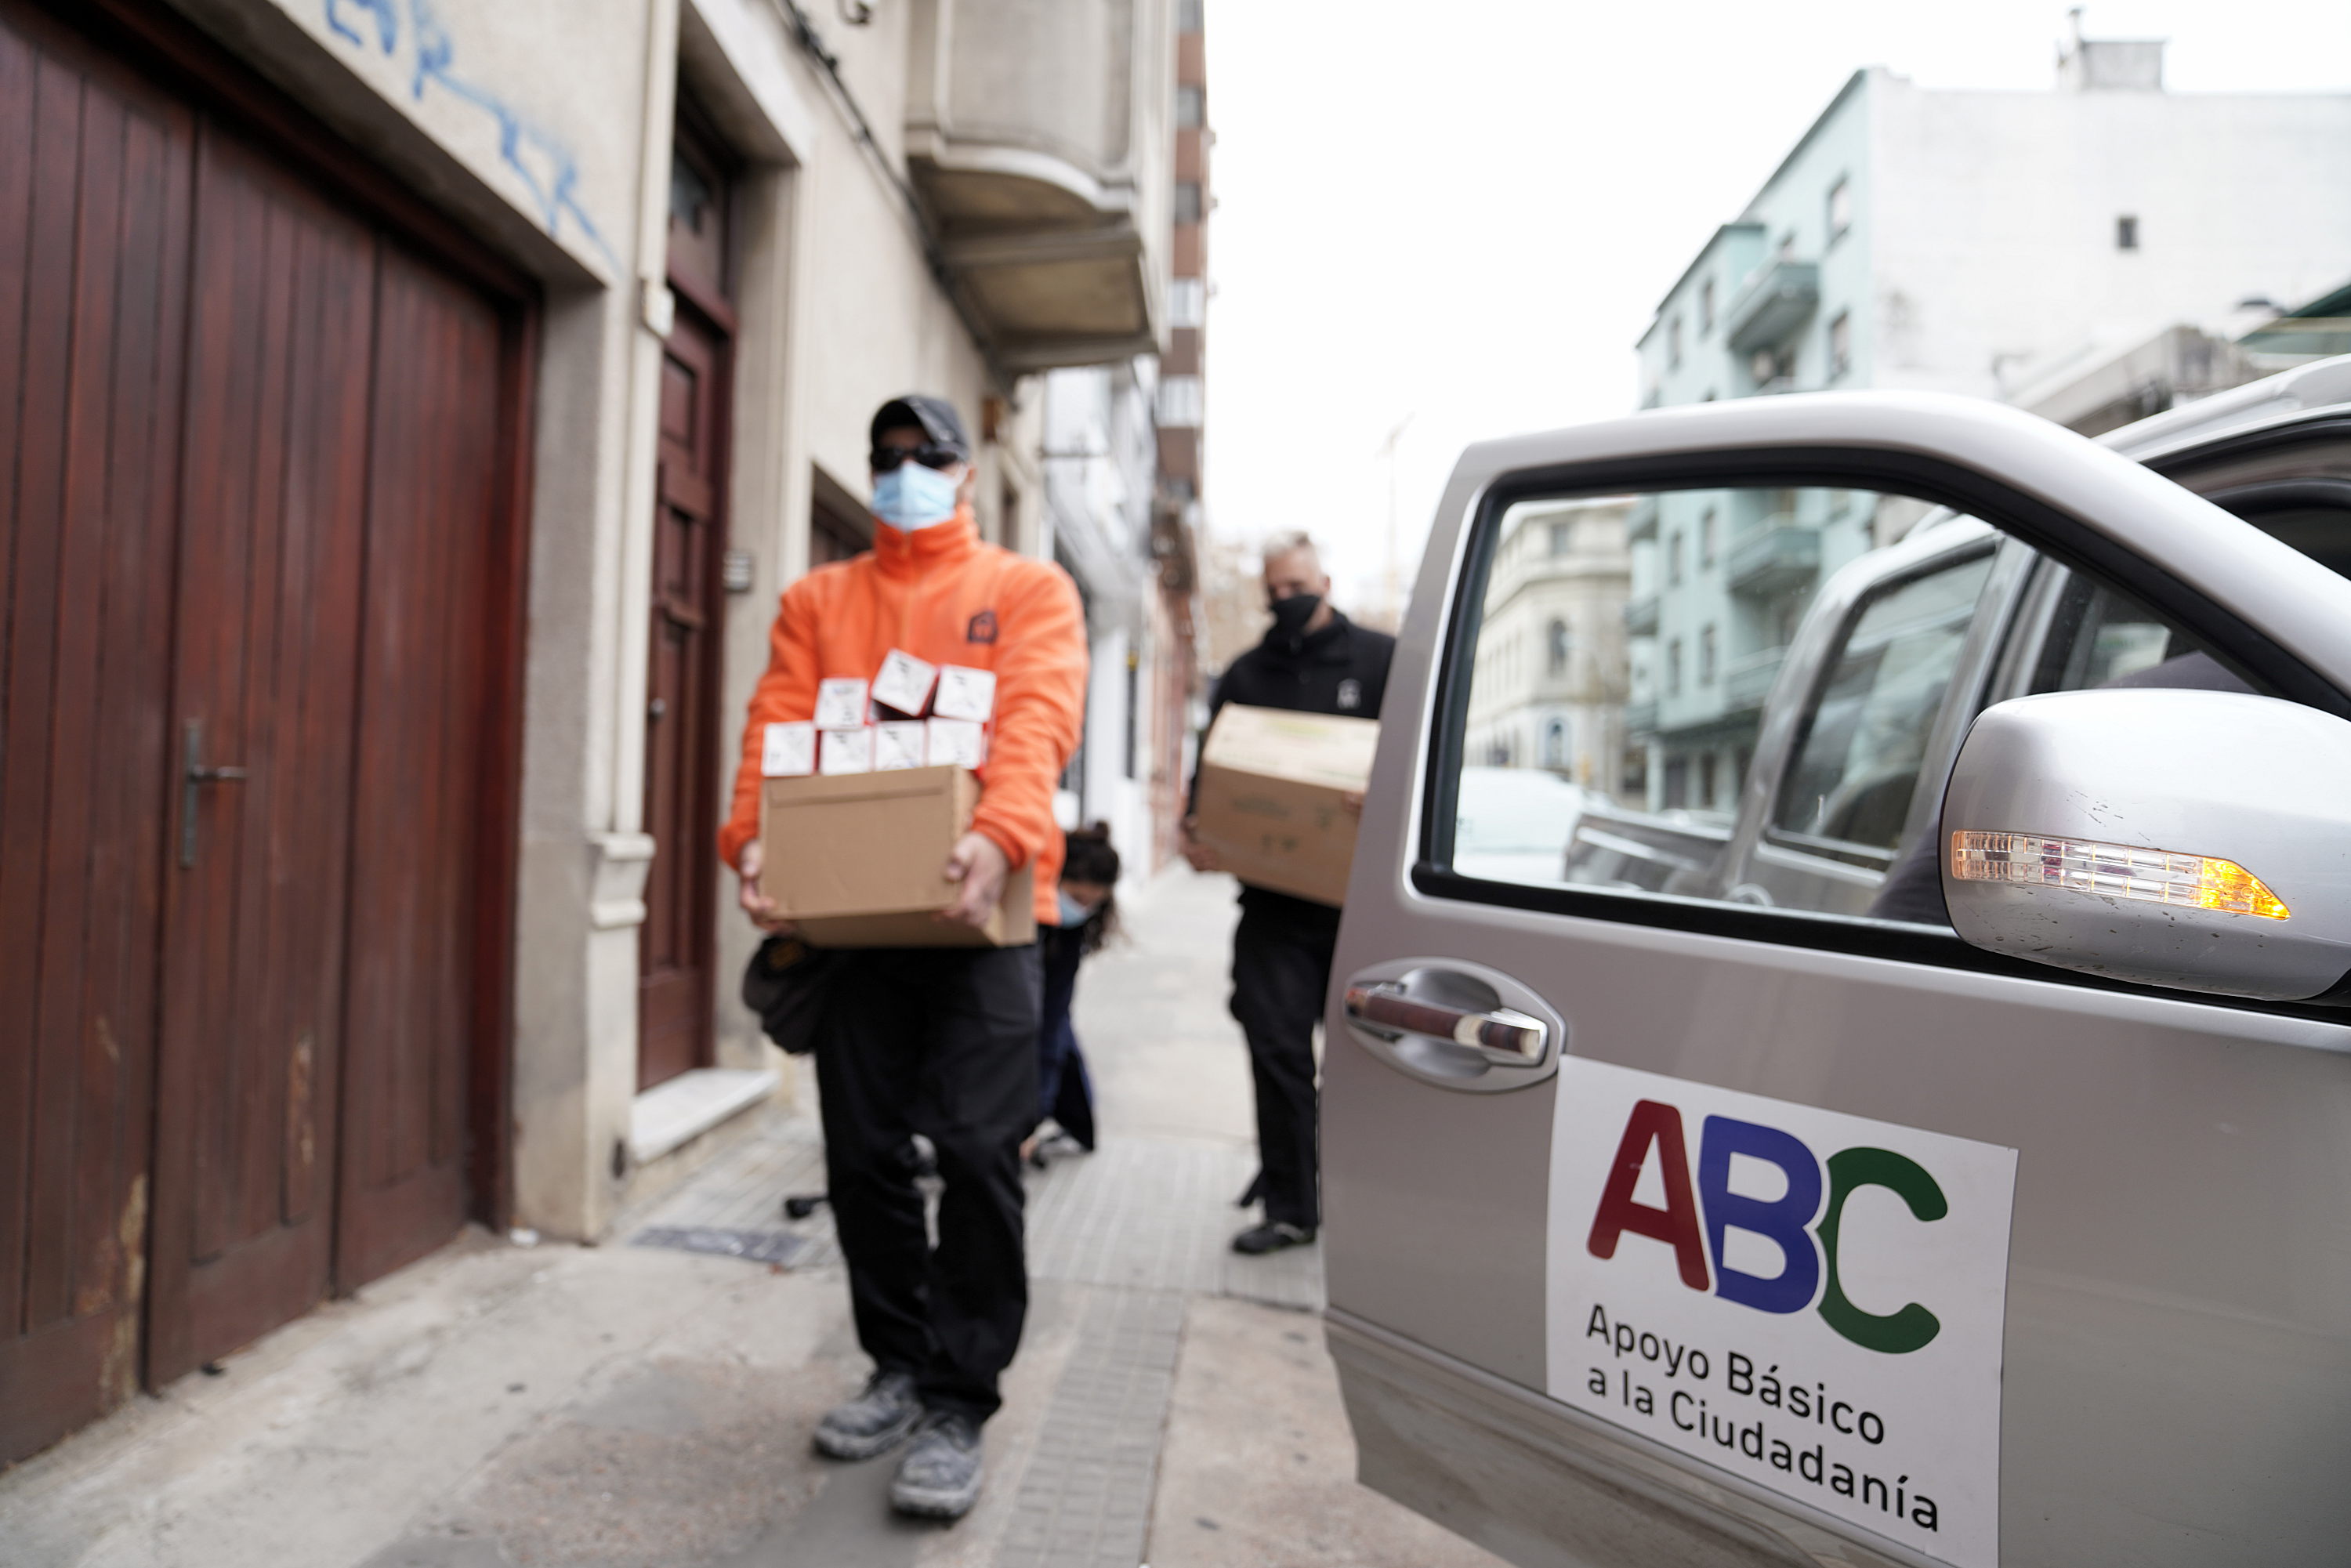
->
[[1415, 461, 2351, 1006]]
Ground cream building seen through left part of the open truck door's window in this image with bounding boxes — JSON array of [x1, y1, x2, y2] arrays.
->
[[1462, 501, 1634, 797]]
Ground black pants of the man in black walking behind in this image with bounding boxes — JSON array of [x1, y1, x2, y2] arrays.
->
[[1232, 886, 1338, 1227]]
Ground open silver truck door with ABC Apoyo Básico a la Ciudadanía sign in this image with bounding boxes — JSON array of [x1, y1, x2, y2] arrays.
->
[[1324, 395, 2351, 1568]]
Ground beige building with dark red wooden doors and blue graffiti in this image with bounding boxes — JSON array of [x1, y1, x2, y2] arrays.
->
[[0, 0, 1197, 1460]]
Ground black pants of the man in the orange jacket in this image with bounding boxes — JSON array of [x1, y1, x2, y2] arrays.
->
[[816, 945, 1039, 1420]]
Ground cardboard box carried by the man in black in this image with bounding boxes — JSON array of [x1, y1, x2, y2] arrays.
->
[[1192, 703, 1380, 905]]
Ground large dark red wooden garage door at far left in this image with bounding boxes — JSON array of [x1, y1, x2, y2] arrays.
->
[[0, 0, 513, 1460]]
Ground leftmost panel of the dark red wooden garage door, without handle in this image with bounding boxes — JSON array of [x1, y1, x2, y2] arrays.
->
[[0, 12, 195, 1460]]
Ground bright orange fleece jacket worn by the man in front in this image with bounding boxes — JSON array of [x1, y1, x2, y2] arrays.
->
[[719, 508, 1086, 924]]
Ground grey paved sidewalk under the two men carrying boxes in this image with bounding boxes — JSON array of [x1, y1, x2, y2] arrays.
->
[[0, 865, 1495, 1568]]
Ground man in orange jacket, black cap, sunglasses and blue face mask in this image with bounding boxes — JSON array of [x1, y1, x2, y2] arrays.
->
[[719, 395, 1086, 1519]]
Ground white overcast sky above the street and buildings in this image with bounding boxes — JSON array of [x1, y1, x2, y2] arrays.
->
[[1206, 0, 2351, 604]]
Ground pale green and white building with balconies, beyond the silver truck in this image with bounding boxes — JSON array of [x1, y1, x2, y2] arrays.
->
[[1627, 40, 2351, 811]]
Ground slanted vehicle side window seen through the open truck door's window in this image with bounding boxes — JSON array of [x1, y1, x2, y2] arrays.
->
[[1773, 545, 1991, 867]]
